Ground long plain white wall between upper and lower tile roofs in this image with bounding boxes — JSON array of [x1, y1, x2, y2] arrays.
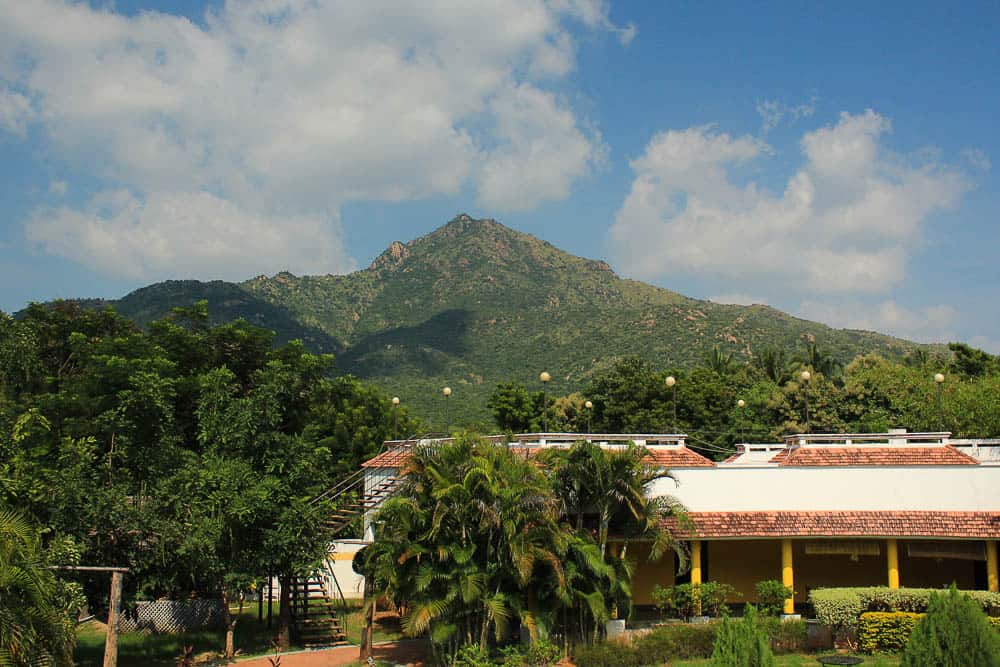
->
[[650, 465, 1000, 512]]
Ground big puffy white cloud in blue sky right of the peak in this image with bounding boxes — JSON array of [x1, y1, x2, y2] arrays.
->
[[611, 110, 969, 295]]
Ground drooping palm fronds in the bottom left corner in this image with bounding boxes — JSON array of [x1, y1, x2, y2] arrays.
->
[[0, 511, 74, 666]]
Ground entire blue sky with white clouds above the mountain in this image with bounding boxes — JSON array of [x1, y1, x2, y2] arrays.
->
[[0, 0, 1000, 352]]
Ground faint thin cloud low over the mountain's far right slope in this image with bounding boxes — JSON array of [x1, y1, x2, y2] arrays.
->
[[799, 299, 960, 343]]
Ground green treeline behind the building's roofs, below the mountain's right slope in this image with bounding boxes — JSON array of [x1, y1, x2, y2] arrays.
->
[[489, 343, 1000, 456]]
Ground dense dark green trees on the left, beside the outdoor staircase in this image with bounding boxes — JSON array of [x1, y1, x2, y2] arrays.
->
[[0, 302, 416, 651]]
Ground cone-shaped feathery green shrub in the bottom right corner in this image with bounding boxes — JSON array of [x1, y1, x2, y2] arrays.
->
[[901, 585, 1000, 667]]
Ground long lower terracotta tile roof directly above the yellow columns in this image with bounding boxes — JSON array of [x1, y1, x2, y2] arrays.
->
[[666, 510, 1000, 539]]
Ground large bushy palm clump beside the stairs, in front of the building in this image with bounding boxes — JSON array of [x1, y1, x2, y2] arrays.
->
[[357, 436, 570, 656]]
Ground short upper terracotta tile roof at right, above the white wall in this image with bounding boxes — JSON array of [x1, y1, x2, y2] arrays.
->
[[771, 445, 979, 466]]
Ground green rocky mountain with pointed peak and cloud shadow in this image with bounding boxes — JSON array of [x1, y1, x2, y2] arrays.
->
[[74, 215, 917, 421]]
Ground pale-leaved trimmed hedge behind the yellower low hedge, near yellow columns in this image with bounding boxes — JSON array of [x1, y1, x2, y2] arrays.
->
[[809, 587, 1000, 628]]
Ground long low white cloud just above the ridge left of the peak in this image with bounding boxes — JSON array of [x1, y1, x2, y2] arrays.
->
[[27, 190, 353, 280]]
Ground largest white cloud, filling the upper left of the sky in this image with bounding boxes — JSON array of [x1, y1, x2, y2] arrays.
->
[[0, 0, 620, 275]]
